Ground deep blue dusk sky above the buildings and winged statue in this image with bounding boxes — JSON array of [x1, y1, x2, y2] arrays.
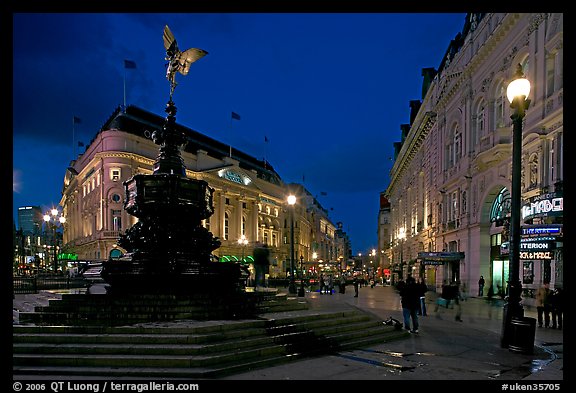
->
[[13, 13, 465, 254]]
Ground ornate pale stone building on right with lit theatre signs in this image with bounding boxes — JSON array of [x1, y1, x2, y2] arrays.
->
[[379, 13, 564, 304]]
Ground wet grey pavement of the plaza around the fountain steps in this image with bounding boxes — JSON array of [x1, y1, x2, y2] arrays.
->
[[13, 286, 564, 382]]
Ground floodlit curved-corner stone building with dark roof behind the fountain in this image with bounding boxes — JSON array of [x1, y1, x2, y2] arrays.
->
[[60, 102, 346, 277]]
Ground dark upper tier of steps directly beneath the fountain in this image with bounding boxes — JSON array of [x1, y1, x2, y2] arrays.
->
[[18, 290, 307, 326]]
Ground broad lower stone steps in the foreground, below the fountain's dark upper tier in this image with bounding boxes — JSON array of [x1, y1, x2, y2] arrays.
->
[[12, 306, 407, 380]]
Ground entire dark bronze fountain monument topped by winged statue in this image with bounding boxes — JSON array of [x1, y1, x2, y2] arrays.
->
[[101, 26, 245, 294]]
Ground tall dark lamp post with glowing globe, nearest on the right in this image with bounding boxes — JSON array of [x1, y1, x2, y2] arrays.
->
[[501, 64, 530, 348]]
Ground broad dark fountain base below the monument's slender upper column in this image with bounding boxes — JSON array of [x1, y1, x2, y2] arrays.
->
[[101, 173, 248, 295]]
